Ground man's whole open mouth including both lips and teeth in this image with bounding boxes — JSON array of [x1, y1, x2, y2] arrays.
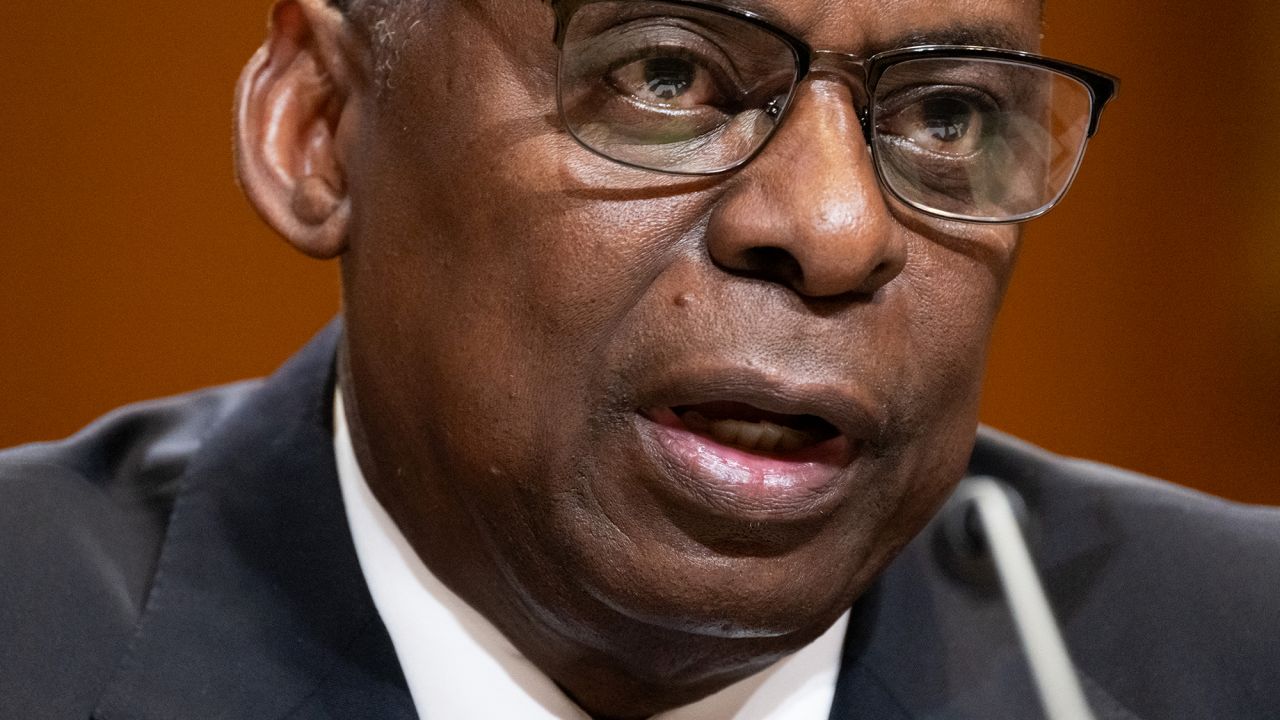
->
[[635, 368, 876, 517]]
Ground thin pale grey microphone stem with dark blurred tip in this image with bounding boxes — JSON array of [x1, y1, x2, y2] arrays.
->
[[940, 475, 1094, 720]]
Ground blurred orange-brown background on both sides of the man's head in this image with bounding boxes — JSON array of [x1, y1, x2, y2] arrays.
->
[[0, 0, 1280, 503]]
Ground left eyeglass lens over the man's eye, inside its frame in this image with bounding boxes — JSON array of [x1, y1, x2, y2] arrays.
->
[[559, 0, 796, 173]]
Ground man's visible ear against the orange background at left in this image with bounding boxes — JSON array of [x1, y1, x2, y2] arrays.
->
[[236, 0, 362, 259]]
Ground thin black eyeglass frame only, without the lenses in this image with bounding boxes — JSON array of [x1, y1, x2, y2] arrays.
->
[[550, 0, 1120, 224]]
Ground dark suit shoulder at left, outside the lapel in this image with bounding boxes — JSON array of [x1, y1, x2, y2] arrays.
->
[[0, 383, 255, 716]]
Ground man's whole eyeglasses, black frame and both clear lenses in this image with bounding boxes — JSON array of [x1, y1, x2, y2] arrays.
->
[[553, 0, 1117, 223]]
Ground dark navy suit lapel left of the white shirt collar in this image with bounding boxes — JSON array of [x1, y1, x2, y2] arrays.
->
[[95, 322, 415, 720]]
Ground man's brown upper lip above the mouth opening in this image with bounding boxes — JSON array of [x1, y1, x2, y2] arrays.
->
[[640, 366, 884, 443]]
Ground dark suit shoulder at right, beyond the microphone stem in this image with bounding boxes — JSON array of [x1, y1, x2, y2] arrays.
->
[[972, 430, 1280, 717]]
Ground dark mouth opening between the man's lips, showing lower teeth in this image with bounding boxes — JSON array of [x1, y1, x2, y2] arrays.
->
[[668, 402, 840, 457]]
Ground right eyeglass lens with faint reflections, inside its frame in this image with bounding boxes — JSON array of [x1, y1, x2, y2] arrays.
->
[[873, 58, 1091, 222]]
